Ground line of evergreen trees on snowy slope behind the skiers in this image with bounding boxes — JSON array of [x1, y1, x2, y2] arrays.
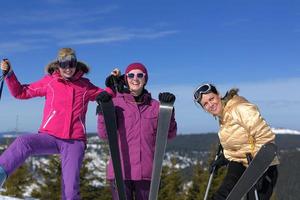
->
[[1, 141, 282, 200]]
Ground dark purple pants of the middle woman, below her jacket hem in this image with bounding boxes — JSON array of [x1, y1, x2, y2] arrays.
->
[[109, 180, 151, 200]]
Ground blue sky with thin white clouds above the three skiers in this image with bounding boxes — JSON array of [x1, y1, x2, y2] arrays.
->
[[0, 0, 300, 134]]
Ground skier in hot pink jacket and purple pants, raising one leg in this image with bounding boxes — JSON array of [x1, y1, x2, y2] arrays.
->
[[0, 48, 113, 200]]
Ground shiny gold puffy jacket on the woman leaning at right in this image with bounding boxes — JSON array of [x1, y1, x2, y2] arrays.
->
[[219, 91, 279, 166]]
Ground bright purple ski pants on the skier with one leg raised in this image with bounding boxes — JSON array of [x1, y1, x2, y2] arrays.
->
[[0, 133, 85, 200]]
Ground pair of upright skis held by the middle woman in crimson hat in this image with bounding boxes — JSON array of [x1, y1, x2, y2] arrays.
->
[[100, 97, 173, 200]]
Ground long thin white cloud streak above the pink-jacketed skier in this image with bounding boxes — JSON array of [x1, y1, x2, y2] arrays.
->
[[0, 28, 178, 54]]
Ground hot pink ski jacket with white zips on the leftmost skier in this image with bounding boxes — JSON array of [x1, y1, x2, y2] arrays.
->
[[5, 71, 114, 141]]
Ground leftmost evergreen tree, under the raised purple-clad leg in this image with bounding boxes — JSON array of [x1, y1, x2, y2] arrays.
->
[[1, 163, 33, 198]]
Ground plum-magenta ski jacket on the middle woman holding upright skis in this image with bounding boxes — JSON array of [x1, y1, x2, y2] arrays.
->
[[98, 93, 177, 180]]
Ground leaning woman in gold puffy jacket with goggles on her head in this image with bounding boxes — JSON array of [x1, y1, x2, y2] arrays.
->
[[194, 84, 279, 200]]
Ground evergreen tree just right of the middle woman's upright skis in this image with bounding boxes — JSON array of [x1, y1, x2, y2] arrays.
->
[[158, 158, 183, 200]]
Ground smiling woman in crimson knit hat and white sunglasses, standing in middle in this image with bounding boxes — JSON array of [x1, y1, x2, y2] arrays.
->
[[98, 63, 177, 200]]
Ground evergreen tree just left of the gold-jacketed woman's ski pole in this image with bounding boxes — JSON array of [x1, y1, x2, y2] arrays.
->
[[186, 161, 208, 200]]
